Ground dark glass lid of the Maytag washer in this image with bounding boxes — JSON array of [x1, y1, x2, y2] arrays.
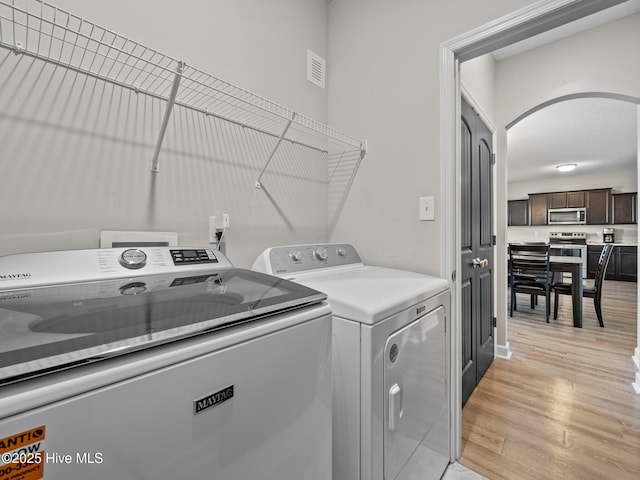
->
[[0, 268, 326, 385]]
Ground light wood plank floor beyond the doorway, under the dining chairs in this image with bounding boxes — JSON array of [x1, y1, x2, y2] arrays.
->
[[460, 280, 640, 480]]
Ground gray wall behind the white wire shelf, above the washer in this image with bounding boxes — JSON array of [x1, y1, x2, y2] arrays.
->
[[0, 0, 328, 267]]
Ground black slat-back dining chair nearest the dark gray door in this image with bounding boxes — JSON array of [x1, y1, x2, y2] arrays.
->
[[509, 243, 551, 323]]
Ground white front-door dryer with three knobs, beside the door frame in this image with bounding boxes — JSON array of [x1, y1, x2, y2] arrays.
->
[[253, 244, 453, 480]]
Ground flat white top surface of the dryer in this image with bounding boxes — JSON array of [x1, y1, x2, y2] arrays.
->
[[290, 265, 448, 325]]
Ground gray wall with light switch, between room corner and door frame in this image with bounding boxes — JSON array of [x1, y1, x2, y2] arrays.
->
[[329, 0, 533, 274]]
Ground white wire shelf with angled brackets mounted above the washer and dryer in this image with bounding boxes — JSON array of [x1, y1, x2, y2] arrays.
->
[[0, 0, 367, 178]]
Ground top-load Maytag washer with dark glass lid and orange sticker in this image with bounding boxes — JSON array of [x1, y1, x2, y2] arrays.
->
[[0, 247, 331, 480]]
